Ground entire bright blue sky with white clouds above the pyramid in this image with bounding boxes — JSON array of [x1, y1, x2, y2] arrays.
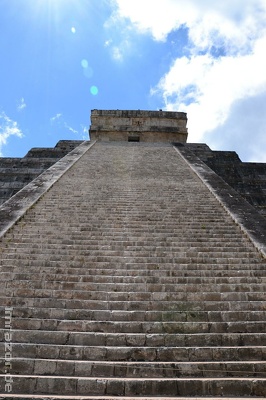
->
[[0, 0, 266, 162]]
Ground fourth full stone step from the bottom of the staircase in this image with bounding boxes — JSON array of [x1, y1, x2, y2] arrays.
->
[[9, 329, 266, 347]]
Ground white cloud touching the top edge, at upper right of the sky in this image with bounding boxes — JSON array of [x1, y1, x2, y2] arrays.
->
[[113, 0, 266, 48]]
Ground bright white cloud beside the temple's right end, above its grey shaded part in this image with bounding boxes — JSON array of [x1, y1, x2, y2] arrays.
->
[[157, 37, 266, 141]]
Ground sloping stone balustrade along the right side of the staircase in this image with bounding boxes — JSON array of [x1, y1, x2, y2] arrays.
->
[[174, 143, 266, 258]]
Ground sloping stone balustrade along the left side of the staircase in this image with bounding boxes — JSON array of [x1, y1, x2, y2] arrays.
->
[[0, 141, 96, 238]]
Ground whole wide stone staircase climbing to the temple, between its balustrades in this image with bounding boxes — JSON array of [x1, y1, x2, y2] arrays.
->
[[0, 142, 266, 399]]
